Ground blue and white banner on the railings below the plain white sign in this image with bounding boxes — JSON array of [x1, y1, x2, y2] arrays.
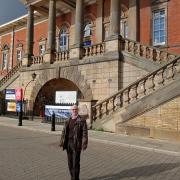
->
[[45, 105, 71, 119]]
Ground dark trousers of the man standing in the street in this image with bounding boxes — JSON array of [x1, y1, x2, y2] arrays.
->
[[67, 142, 81, 180]]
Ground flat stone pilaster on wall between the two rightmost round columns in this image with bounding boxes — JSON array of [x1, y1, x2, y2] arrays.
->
[[96, 0, 104, 43]]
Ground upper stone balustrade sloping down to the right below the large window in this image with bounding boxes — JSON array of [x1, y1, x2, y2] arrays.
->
[[121, 38, 178, 63]]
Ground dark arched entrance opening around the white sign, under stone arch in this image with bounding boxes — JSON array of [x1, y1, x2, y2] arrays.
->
[[34, 78, 84, 116]]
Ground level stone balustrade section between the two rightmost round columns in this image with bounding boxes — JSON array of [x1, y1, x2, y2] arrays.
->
[[83, 43, 105, 57]]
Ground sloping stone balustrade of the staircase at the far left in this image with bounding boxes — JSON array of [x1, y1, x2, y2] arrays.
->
[[0, 61, 22, 87]]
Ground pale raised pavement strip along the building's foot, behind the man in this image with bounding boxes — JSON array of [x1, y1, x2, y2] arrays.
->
[[0, 116, 180, 156]]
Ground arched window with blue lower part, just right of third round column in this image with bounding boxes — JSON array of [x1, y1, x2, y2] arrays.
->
[[83, 22, 91, 46]]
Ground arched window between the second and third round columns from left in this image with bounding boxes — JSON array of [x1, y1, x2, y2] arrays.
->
[[59, 26, 68, 51]]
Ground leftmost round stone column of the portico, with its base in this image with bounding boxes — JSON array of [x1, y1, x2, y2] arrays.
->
[[22, 5, 34, 66]]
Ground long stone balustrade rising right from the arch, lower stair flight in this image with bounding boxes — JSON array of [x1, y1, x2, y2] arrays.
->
[[92, 56, 180, 121]]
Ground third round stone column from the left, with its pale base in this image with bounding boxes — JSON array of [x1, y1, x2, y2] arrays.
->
[[70, 0, 84, 59]]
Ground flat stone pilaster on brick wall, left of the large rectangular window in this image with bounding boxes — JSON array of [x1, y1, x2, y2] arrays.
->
[[128, 0, 139, 41]]
